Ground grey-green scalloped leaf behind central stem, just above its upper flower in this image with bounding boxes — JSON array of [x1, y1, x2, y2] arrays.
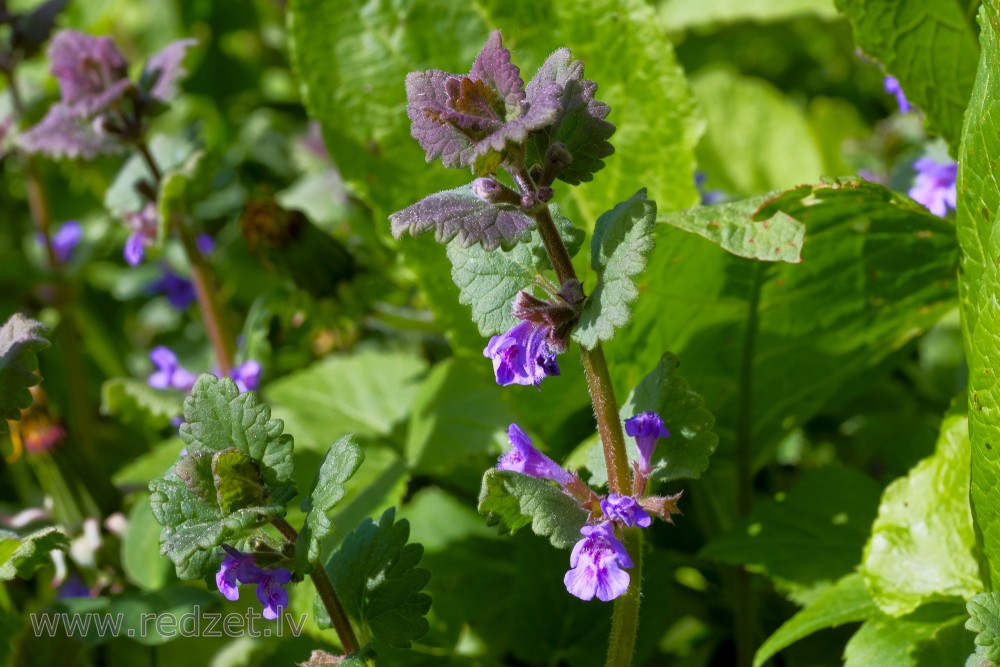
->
[[448, 205, 585, 336]]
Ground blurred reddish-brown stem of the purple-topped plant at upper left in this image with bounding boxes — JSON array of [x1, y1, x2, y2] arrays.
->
[[136, 140, 235, 375]]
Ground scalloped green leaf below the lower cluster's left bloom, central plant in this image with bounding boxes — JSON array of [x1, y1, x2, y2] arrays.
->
[[479, 468, 588, 549]]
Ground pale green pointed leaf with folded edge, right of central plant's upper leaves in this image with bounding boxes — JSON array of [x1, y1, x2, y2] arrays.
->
[[656, 196, 806, 264]]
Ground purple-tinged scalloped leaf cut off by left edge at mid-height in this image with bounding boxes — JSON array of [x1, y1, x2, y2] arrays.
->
[[0, 313, 49, 433]]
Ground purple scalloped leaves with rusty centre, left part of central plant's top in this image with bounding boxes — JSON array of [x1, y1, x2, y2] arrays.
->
[[406, 30, 562, 174]]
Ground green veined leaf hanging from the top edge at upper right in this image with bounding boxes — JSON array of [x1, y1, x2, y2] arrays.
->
[[836, 0, 979, 148]]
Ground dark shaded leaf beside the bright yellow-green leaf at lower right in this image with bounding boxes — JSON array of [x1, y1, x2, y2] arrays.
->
[[701, 467, 879, 585]]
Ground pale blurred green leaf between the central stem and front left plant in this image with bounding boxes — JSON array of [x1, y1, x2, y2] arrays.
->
[[267, 350, 427, 450]]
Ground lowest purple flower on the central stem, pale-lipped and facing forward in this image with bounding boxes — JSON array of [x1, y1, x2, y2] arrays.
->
[[563, 521, 632, 602]]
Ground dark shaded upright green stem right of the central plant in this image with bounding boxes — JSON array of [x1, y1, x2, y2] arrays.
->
[[734, 262, 764, 667]]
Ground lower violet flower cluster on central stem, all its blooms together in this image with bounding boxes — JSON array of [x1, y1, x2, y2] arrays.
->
[[497, 412, 680, 602]]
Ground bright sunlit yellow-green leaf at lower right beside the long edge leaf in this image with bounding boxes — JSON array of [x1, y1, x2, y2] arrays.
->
[[861, 406, 982, 616]]
